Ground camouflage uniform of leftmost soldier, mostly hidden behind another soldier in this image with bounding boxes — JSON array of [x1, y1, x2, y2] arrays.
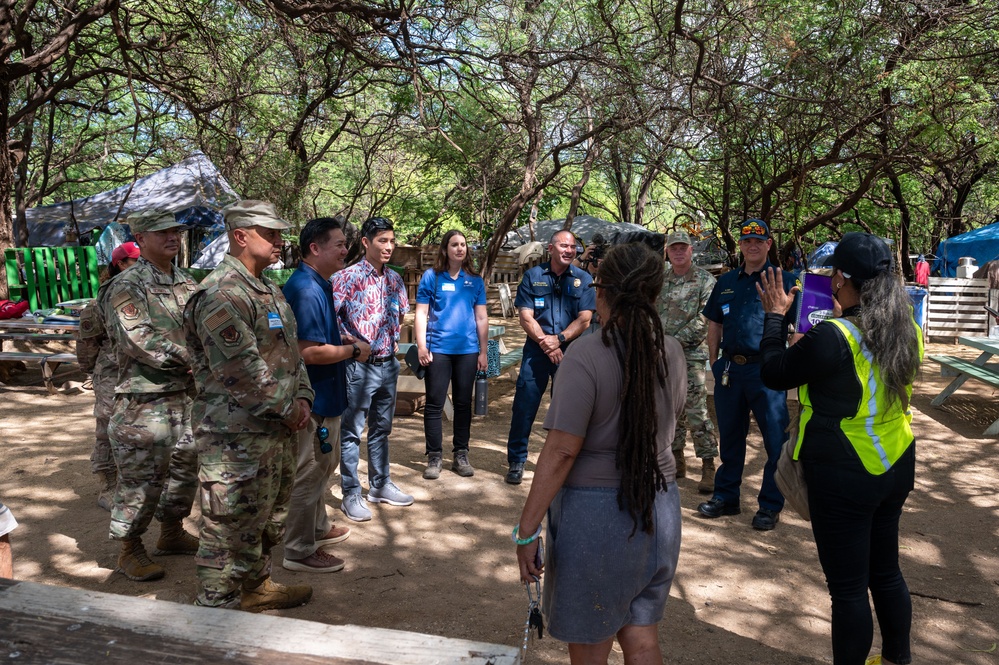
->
[[76, 281, 118, 474]]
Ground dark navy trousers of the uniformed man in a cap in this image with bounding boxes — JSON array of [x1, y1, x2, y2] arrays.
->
[[711, 357, 790, 511]]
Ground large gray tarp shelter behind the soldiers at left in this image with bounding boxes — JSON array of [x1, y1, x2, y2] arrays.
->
[[25, 152, 240, 247]]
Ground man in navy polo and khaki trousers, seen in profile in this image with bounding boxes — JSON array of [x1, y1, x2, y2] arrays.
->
[[282, 216, 371, 573]]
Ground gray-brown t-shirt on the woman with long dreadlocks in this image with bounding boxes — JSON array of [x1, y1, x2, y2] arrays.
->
[[544, 334, 687, 487]]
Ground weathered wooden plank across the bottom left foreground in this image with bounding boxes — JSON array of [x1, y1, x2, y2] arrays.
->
[[0, 579, 520, 665]]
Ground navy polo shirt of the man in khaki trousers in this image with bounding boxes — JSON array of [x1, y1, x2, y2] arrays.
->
[[282, 262, 347, 418]]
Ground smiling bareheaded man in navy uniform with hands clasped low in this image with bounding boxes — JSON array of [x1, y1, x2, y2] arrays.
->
[[506, 231, 597, 485]]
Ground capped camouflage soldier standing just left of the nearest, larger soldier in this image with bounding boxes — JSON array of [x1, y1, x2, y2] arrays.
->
[[101, 210, 198, 581]]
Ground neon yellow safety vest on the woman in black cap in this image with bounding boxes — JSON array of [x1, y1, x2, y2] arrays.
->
[[794, 318, 923, 476]]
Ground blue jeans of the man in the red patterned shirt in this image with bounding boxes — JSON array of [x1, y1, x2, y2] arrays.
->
[[340, 358, 399, 497]]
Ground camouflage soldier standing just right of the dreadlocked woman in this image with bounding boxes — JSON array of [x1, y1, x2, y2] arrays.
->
[[657, 231, 718, 494]]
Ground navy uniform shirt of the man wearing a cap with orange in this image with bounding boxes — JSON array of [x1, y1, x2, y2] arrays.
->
[[701, 261, 798, 356]]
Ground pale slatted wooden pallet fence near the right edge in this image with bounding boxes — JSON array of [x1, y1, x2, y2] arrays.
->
[[927, 277, 999, 341]]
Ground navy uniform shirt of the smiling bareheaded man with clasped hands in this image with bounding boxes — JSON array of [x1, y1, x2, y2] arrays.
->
[[514, 263, 597, 343]]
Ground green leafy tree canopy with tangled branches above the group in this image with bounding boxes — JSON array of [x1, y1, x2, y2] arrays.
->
[[0, 0, 999, 280]]
